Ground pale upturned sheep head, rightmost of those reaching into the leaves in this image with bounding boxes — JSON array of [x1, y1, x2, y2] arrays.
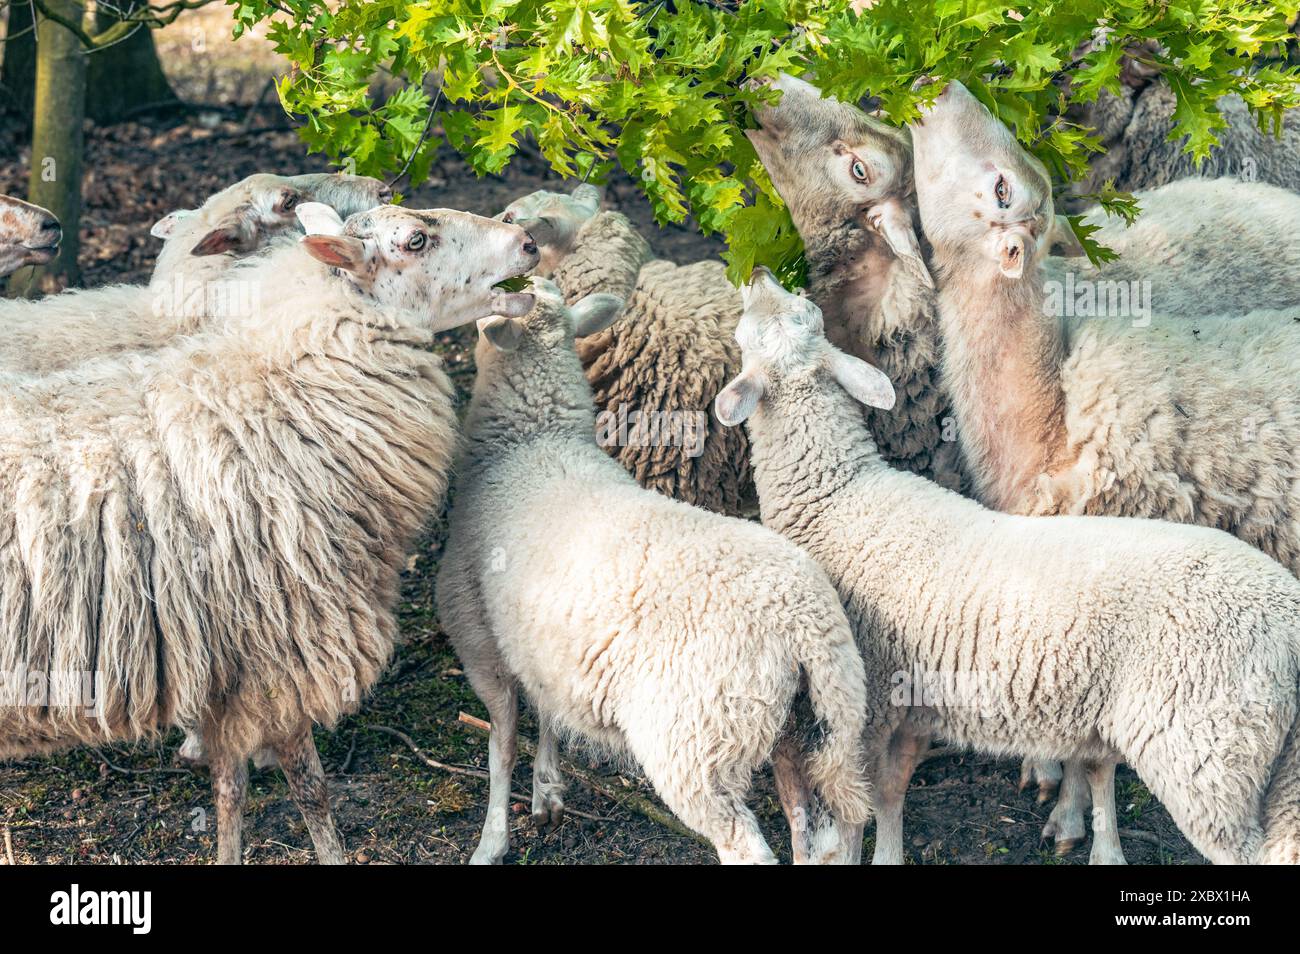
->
[[911, 81, 1083, 279]]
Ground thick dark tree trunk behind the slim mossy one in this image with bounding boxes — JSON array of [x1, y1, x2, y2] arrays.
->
[[86, 4, 181, 125]]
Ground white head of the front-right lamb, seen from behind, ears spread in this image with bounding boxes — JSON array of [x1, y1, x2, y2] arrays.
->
[[714, 268, 894, 426]]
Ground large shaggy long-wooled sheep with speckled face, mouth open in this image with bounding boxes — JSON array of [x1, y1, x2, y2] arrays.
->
[[0, 203, 537, 863]]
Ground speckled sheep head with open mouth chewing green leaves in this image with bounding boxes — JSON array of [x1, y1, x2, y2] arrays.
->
[[298, 203, 538, 331]]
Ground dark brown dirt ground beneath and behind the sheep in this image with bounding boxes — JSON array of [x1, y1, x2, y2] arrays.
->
[[0, 8, 1203, 864]]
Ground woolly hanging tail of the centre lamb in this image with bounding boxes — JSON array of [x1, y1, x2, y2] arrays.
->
[[796, 624, 871, 825]]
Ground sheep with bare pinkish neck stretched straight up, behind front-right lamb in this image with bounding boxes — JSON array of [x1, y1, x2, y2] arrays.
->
[[913, 83, 1300, 863]]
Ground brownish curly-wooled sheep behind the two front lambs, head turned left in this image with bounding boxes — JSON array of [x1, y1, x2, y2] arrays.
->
[[498, 185, 753, 516]]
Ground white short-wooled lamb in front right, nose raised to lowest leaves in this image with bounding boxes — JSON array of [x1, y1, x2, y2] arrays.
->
[[716, 267, 1300, 864]]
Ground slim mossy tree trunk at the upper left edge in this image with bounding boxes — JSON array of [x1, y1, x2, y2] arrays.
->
[[9, 0, 86, 295]]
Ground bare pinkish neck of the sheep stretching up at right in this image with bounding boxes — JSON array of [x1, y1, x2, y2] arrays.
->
[[939, 250, 1066, 512]]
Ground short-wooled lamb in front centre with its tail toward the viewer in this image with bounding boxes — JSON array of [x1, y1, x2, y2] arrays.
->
[[436, 276, 870, 864]]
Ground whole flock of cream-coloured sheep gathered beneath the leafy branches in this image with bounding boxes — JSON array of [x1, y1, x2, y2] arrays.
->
[[0, 67, 1300, 863]]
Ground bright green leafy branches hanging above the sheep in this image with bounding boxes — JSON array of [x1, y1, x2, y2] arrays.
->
[[229, 0, 1300, 281]]
